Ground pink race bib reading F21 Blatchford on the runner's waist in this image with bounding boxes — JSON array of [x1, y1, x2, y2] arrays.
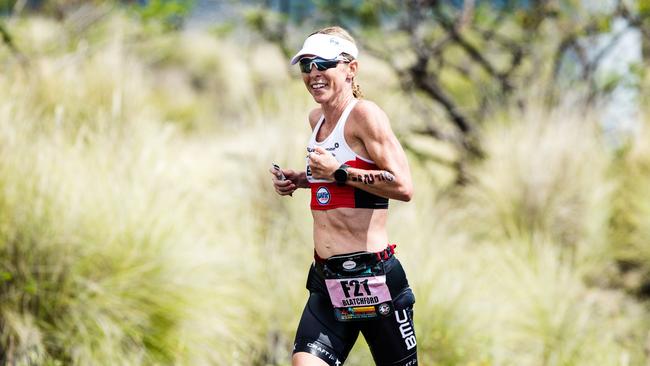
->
[[325, 275, 393, 321]]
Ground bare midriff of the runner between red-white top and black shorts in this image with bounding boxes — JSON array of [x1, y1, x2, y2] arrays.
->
[[311, 208, 388, 258]]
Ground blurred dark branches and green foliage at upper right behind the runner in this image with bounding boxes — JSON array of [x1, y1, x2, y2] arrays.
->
[[264, 0, 648, 162]]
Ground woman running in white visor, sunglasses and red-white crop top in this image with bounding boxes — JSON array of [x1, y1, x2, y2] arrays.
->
[[271, 27, 417, 366]]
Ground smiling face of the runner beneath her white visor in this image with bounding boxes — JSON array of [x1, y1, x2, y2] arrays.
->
[[302, 55, 357, 104]]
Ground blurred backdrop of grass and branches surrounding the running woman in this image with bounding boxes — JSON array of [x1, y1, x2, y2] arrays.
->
[[0, 0, 650, 366]]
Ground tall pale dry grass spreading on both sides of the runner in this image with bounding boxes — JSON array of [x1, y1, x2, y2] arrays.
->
[[0, 8, 650, 365]]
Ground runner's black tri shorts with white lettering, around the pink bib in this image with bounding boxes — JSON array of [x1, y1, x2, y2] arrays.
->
[[293, 253, 418, 366]]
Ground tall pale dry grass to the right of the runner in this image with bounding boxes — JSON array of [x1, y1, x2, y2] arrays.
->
[[394, 105, 648, 365]]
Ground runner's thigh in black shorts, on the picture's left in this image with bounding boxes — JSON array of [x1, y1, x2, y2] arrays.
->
[[293, 292, 359, 366]]
